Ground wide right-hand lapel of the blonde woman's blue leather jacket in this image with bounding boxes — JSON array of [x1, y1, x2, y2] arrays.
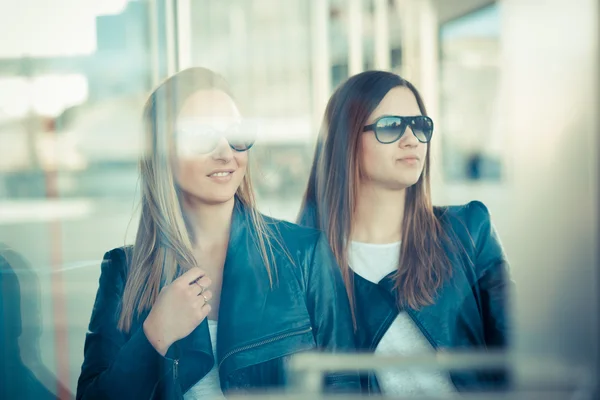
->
[[217, 202, 314, 387]]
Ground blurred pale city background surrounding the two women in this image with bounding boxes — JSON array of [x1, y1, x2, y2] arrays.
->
[[0, 0, 600, 398]]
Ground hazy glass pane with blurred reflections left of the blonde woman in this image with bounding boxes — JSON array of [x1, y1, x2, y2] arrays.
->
[[0, 0, 153, 399]]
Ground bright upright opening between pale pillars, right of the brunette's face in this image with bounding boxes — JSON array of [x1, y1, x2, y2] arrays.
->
[[440, 4, 505, 181]]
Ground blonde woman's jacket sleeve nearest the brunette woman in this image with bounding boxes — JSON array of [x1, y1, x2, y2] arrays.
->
[[307, 234, 360, 392]]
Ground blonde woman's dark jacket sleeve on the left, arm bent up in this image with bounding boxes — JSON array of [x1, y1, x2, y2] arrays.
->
[[77, 249, 171, 399]]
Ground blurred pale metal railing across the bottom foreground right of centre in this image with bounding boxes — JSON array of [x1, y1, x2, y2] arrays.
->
[[230, 351, 597, 400]]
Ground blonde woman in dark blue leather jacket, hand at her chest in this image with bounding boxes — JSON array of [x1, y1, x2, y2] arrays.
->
[[77, 68, 359, 399]]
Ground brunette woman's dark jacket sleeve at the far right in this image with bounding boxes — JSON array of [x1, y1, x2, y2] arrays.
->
[[469, 201, 513, 348]]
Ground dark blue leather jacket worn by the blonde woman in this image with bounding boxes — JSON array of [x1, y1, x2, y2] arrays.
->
[[77, 202, 360, 399]]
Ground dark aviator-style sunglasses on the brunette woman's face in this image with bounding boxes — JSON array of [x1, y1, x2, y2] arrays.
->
[[363, 115, 433, 144]]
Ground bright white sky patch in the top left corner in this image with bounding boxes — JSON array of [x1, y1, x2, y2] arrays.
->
[[0, 0, 127, 58]]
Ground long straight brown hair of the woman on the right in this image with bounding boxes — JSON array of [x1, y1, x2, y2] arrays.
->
[[298, 71, 451, 317]]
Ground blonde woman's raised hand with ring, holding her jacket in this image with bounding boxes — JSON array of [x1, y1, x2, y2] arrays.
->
[[143, 267, 212, 356]]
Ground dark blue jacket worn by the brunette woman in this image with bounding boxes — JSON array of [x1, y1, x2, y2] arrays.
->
[[301, 201, 512, 392]]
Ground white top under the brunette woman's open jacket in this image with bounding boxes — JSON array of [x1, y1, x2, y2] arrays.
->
[[349, 242, 456, 396]]
